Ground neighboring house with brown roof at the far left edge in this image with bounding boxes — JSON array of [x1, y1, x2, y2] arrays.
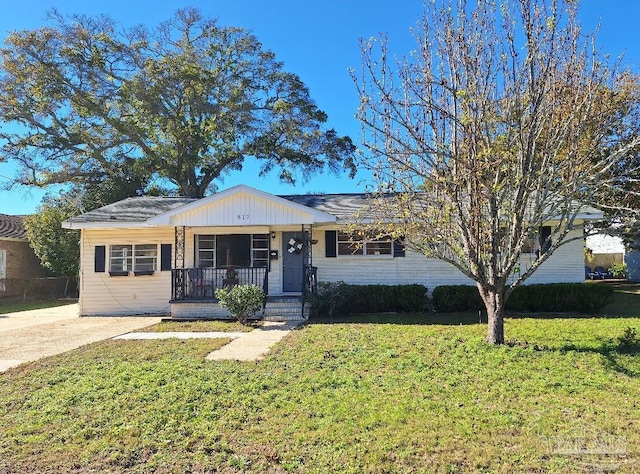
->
[[0, 214, 45, 297]]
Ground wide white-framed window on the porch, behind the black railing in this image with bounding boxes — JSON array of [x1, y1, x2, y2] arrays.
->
[[196, 234, 269, 268]]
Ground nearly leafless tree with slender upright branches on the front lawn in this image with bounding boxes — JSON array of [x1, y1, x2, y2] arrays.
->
[[354, 0, 638, 344]]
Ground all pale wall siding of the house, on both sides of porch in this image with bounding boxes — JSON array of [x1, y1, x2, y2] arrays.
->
[[80, 226, 584, 316]]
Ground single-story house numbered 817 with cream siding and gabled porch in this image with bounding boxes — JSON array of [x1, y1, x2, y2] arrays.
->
[[63, 185, 599, 319]]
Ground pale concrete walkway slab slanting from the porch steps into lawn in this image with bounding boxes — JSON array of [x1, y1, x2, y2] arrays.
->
[[207, 321, 304, 361]]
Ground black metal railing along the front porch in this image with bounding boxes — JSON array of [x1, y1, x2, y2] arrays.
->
[[171, 267, 267, 300]]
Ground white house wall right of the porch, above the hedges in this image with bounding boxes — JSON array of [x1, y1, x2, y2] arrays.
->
[[313, 224, 584, 293]]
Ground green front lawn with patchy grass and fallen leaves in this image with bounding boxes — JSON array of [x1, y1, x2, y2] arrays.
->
[[0, 293, 640, 473]]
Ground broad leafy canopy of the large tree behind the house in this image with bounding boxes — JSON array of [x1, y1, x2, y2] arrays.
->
[[0, 8, 355, 196]]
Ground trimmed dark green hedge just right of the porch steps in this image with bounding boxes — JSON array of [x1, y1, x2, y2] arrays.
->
[[309, 281, 427, 317]]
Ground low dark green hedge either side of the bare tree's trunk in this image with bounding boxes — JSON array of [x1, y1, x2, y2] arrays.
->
[[433, 283, 615, 313]]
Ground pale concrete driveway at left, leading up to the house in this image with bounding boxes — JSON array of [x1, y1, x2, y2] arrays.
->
[[0, 304, 161, 372]]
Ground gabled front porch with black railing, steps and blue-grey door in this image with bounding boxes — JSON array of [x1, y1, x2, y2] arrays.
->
[[148, 186, 336, 320]]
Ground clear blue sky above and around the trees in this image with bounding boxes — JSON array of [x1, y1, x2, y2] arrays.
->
[[0, 0, 640, 214]]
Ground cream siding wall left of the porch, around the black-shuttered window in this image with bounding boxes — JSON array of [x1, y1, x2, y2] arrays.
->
[[80, 228, 175, 316]]
